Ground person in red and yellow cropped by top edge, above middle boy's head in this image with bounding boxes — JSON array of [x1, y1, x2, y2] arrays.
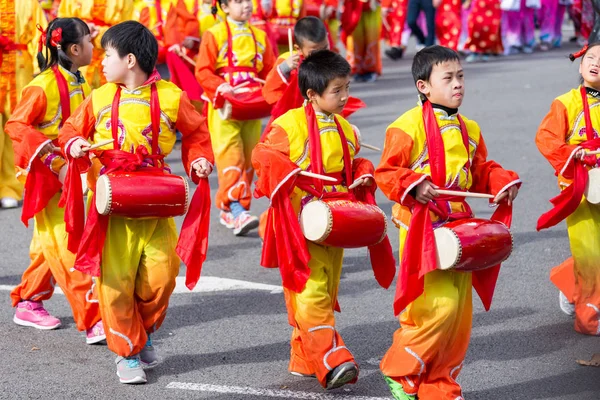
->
[[341, 0, 381, 82]]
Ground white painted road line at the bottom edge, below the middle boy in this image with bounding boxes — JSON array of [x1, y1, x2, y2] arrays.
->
[[166, 382, 390, 400]]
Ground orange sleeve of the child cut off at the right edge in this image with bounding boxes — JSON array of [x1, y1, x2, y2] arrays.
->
[[535, 100, 577, 173]]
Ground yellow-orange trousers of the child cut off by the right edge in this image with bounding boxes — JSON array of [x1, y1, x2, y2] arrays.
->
[[567, 199, 600, 336]]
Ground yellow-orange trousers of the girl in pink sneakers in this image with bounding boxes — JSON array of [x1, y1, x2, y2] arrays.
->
[[10, 194, 100, 331]]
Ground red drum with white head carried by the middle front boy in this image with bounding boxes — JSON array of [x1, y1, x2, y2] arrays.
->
[[300, 199, 387, 249]]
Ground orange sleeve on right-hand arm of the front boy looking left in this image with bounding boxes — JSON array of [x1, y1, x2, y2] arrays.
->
[[175, 92, 215, 183]]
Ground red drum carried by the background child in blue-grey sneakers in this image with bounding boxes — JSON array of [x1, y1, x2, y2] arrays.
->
[[215, 88, 273, 121]]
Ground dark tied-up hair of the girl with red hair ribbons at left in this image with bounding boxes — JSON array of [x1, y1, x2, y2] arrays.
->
[[37, 18, 90, 71]]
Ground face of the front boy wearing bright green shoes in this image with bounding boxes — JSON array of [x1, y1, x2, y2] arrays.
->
[[417, 61, 465, 108]]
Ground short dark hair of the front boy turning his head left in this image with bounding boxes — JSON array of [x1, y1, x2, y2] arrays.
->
[[101, 21, 158, 75]]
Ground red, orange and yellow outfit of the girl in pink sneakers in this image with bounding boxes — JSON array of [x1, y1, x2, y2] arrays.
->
[[6, 67, 100, 330]]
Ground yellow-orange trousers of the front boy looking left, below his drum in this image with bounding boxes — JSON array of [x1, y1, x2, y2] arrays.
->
[[97, 217, 180, 357]]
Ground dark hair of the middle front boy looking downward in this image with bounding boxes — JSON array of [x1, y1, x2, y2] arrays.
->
[[298, 50, 351, 100]]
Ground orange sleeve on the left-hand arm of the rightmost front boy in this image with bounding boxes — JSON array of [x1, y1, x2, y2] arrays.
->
[[375, 127, 427, 205]]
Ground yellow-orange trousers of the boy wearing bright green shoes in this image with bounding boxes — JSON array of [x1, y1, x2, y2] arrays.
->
[[380, 228, 473, 400]]
